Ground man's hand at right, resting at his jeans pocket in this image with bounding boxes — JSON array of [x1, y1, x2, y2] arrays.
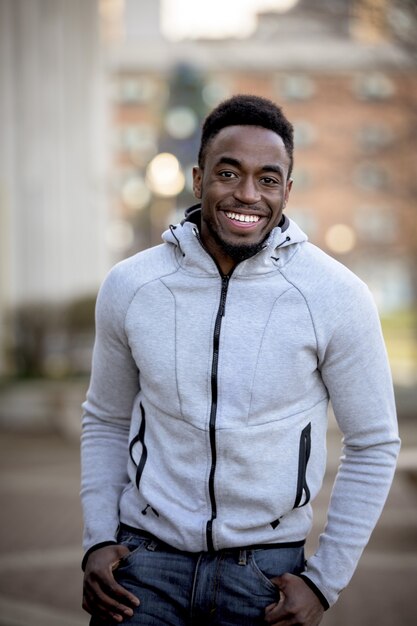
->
[[265, 574, 324, 626]]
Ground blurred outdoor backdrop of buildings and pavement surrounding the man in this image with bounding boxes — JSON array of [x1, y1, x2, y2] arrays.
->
[[0, 0, 417, 626]]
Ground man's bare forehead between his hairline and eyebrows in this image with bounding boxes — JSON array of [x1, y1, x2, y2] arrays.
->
[[206, 126, 290, 169]]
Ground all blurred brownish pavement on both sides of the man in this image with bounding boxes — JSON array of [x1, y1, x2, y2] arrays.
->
[[0, 380, 417, 626]]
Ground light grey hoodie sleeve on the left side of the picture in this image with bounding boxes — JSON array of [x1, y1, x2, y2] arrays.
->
[[81, 265, 139, 552]]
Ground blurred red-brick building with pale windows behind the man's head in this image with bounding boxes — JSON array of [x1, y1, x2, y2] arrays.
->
[[102, 0, 417, 312]]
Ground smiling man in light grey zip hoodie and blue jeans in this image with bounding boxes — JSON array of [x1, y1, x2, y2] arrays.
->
[[82, 96, 399, 626]]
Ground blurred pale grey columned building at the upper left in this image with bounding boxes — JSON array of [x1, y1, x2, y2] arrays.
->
[[0, 0, 110, 373]]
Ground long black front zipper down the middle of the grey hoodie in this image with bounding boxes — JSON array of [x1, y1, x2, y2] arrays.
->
[[206, 274, 230, 552]]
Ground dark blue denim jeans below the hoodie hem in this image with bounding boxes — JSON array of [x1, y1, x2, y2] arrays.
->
[[90, 529, 304, 626]]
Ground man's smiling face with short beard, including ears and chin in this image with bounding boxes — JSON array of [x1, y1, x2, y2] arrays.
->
[[194, 125, 292, 274]]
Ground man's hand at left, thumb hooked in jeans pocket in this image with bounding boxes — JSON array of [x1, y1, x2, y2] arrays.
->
[[83, 545, 140, 623]]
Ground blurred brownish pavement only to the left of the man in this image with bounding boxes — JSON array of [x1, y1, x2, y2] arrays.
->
[[0, 431, 88, 626]]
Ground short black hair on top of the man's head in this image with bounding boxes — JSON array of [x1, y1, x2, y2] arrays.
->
[[198, 94, 294, 176]]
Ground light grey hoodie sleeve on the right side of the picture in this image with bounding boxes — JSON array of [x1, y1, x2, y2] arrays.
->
[[303, 280, 399, 605]]
